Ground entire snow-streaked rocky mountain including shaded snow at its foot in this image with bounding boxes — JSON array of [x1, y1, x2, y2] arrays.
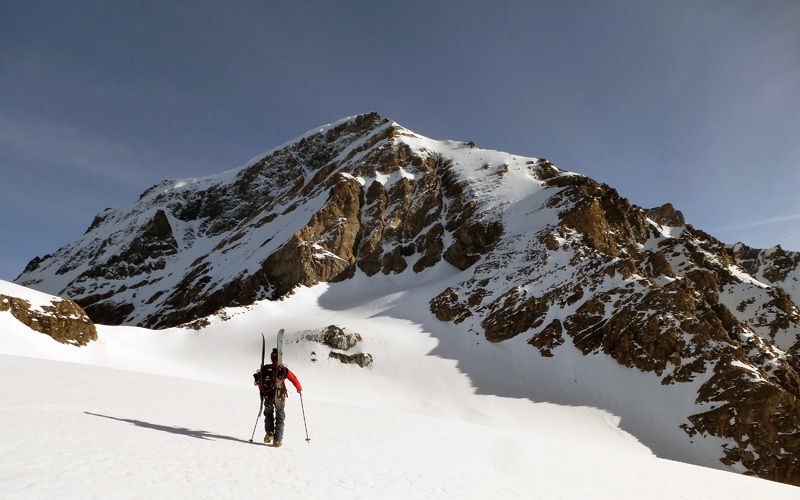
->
[[16, 114, 800, 484]]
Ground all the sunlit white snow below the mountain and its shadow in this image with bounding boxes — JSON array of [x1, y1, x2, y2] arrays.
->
[[0, 280, 799, 499]]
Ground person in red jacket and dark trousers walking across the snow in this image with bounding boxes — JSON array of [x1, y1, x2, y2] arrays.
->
[[253, 348, 303, 447]]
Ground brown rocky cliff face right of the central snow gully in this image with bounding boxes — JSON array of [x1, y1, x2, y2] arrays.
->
[[431, 169, 800, 485]]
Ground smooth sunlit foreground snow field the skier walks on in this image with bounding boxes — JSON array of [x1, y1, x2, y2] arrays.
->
[[0, 355, 796, 499]]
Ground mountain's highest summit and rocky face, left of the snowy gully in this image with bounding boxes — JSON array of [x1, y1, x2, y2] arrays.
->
[[17, 113, 512, 327]]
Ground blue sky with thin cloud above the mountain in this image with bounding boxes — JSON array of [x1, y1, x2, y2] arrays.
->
[[0, 0, 800, 280]]
